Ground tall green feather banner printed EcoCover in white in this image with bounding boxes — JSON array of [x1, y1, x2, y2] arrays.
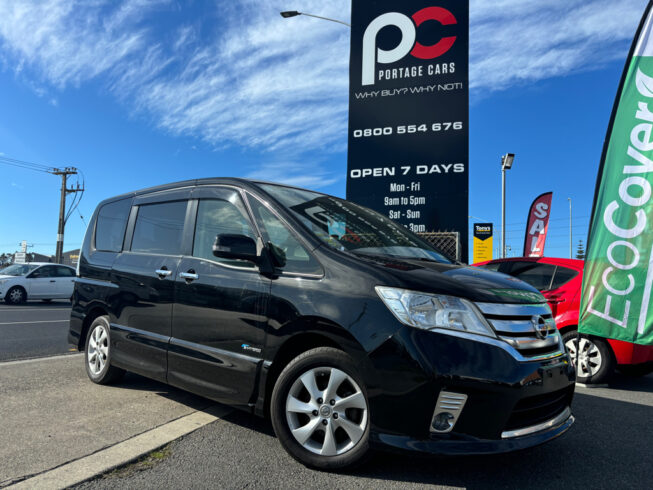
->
[[579, 3, 653, 345]]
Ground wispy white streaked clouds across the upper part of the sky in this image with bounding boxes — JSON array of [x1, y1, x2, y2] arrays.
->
[[0, 0, 646, 182]]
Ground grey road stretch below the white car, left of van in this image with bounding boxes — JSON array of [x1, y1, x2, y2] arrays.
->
[[0, 301, 71, 361]]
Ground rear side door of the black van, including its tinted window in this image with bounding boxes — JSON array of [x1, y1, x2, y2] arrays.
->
[[109, 190, 192, 381]]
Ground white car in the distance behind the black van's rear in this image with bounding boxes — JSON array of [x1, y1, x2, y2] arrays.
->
[[0, 262, 76, 304]]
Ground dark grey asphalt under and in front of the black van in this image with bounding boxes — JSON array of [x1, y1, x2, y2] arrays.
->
[[77, 375, 653, 490]]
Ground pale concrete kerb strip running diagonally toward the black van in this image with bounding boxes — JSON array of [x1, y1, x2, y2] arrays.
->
[[7, 405, 233, 490]]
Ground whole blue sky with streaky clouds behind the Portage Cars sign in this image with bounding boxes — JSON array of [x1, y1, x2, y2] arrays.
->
[[0, 0, 646, 256]]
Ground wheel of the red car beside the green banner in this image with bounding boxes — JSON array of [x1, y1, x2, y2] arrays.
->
[[562, 330, 616, 384]]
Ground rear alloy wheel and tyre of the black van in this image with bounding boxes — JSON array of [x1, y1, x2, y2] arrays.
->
[[84, 316, 125, 385]]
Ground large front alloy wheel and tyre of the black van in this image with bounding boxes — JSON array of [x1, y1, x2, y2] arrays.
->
[[270, 347, 370, 470]]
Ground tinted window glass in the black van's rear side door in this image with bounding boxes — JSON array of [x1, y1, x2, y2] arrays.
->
[[131, 201, 187, 255]]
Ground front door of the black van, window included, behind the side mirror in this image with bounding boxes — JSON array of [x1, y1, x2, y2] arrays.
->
[[168, 187, 270, 406]]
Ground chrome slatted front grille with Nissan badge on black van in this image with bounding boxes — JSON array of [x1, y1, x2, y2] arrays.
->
[[477, 303, 564, 360]]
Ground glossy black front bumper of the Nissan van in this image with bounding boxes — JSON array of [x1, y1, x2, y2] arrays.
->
[[369, 327, 575, 454]]
